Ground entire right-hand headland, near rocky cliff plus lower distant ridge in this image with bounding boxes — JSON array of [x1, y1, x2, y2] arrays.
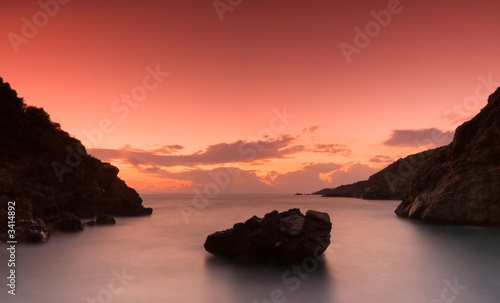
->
[[313, 88, 500, 226]]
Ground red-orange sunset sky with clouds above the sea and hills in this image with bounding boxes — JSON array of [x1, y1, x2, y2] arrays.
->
[[0, 0, 500, 193]]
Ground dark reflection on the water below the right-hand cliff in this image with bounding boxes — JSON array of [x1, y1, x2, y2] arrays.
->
[[413, 223, 500, 302]]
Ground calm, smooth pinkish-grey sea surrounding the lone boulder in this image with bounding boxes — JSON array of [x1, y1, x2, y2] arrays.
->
[[0, 195, 500, 303]]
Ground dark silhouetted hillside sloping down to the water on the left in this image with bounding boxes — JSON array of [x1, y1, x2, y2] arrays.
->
[[0, 78, 153, 242]]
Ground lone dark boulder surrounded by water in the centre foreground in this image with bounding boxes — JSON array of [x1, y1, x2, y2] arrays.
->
[[205, 209, 332, 263]]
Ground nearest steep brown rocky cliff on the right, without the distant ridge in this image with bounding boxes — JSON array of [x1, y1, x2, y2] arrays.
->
[[395, 88, 500, 226]]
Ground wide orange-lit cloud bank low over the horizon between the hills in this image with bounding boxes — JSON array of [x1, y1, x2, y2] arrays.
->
[[89, 135, 379, 193]]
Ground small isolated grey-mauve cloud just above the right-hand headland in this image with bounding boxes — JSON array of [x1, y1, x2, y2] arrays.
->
[[384, 128, 454, 147]]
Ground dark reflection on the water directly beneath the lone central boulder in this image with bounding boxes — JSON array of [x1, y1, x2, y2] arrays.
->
[[205, 256, 334, 303]]
